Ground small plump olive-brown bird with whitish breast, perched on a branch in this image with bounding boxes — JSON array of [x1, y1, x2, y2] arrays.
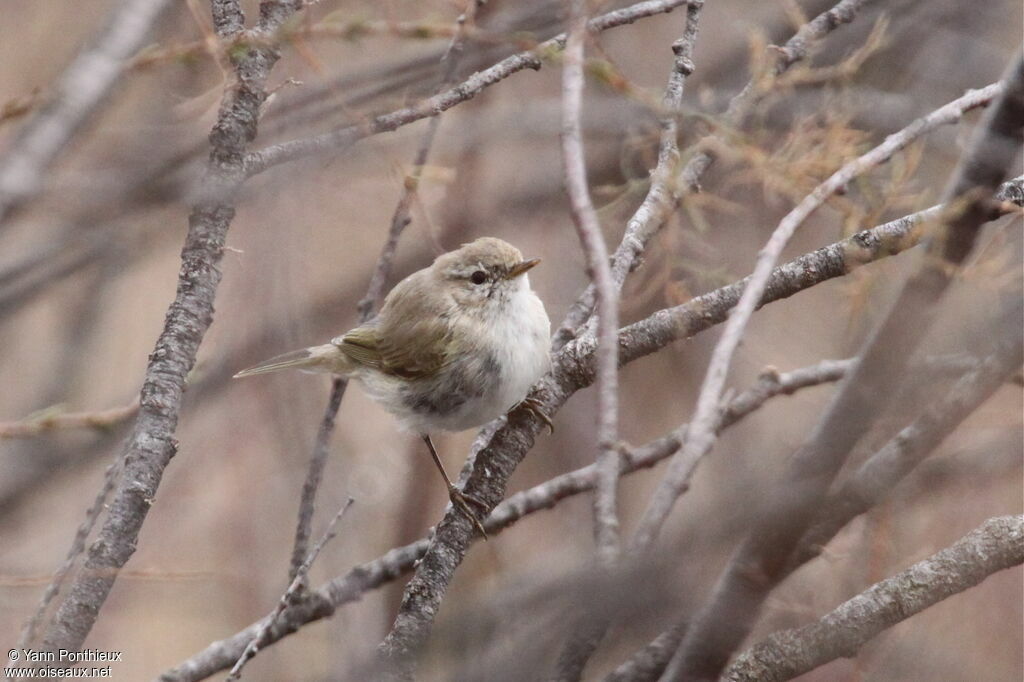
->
[[234, 237, 554, 538]]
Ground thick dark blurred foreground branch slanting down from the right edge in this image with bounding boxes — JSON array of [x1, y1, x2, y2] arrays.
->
[[666, 50, 1024, 680]]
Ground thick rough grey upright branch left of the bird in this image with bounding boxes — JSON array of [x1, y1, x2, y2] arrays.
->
[[32, 0, 296, 650]]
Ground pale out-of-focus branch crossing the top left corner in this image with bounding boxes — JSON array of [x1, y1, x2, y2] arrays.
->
[[0, 0, 171, 223]]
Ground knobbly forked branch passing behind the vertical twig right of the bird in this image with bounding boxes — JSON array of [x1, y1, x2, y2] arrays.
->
[[552, 0, 868, 350]]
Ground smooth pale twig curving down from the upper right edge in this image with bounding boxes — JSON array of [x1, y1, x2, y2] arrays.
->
[[633, 78, 1004, 548]]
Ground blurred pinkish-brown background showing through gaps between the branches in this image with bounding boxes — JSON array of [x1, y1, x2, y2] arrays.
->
[[0, 0, 1024, 680]]
